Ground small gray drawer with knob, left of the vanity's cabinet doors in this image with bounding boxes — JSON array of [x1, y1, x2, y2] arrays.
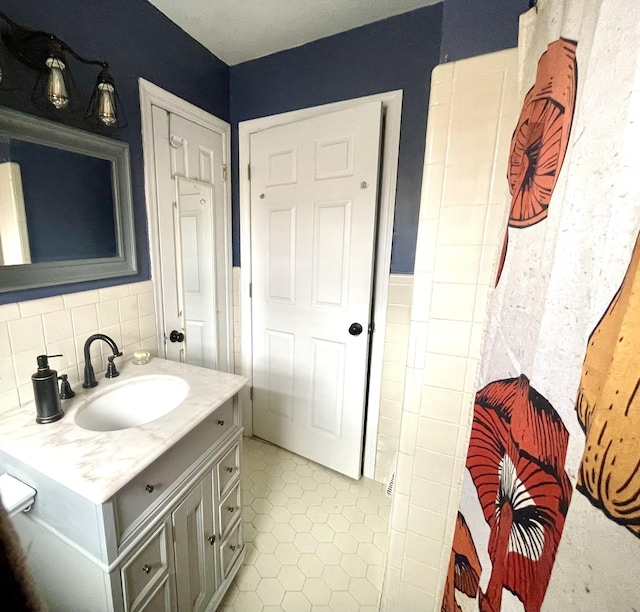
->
[[120, 523, 169, 610]]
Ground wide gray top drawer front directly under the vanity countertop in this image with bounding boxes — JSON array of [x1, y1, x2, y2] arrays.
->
[[113, 399, 235, 542]]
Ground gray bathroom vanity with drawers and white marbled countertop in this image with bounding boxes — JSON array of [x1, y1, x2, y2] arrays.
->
[[0, 358, 247, 612]]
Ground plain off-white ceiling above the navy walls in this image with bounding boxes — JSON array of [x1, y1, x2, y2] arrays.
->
[[149, 0, 442, 66]]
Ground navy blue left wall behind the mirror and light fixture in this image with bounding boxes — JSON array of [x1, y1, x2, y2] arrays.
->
[[0, 0, 229, 303]]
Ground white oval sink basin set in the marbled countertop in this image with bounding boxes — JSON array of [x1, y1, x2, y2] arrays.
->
[[76, 374, 189, 431]]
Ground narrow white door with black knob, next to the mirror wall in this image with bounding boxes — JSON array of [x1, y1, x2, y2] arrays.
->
[[153, 107, 231, 370]]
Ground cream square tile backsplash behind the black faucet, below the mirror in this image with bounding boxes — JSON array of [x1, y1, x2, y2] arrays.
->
[[0, 281, 158, 410]]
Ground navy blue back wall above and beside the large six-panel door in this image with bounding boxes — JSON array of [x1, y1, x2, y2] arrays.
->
[[230, 4, 442, 273]]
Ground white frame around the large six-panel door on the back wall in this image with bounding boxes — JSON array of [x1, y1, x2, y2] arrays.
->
[[238, 89, 402, 479]]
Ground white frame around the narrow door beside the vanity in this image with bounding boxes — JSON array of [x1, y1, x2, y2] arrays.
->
[[138, 78, 234, 371]]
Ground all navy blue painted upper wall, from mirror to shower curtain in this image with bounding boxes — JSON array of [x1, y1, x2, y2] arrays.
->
[[0, 0, 529, 303]]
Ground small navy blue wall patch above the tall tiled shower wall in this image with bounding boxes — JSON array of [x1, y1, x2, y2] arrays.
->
[[440, 0, 530, 63]]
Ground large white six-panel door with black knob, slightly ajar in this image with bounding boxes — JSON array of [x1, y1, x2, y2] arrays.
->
[[251, 102, 382, 478]]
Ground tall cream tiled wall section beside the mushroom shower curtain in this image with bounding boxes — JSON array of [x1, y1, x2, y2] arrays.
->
[[381, 49, 519, 612]]
